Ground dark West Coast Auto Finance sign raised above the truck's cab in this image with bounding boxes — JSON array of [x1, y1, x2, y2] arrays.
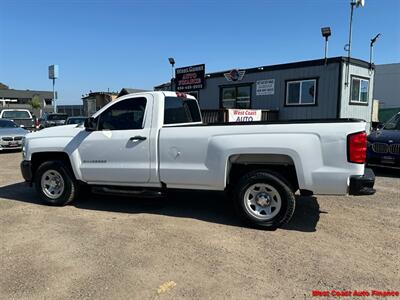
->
[[175, 64, 205, 91]]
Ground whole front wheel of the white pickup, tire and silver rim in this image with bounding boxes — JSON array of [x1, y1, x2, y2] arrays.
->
[[35, 161, 77, 206]]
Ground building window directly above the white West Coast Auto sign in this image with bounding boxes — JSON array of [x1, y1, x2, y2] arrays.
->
[[221, 85, 251, 109]]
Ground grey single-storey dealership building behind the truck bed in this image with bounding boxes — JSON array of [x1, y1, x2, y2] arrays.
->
[[154, 57, 374, 127]]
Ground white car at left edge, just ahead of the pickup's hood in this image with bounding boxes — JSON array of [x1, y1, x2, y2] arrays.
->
[[0, 119, 28, 151]]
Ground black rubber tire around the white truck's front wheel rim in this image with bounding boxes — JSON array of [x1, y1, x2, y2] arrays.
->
[[35, 161, 78, 206]]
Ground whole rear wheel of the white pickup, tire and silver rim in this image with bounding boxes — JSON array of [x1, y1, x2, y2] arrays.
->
[[233, 171, 295, 228]]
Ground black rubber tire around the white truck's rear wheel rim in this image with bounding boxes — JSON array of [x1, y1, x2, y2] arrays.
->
[[233, 170, 296, 228]]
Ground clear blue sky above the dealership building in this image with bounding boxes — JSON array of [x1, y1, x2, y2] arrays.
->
[[0, 0, 400, 104]]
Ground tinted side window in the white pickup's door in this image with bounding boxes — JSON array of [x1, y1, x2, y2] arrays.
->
[[98, 98, 146, 130]]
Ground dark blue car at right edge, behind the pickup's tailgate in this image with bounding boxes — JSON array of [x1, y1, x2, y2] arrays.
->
[[367, 112, 400, 167]]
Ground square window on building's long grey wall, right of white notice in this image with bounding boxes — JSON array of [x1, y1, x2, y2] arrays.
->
[[286, 79, 317, 106]]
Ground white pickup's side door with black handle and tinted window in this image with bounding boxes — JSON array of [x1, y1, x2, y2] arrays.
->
[[78, 95, 153, 184]]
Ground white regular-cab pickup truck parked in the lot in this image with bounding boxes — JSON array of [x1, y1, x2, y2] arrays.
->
[[21, 92, 375, 227]]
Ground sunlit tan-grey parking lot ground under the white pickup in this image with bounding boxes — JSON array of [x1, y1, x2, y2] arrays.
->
[[0, 152, 400, 299]]
